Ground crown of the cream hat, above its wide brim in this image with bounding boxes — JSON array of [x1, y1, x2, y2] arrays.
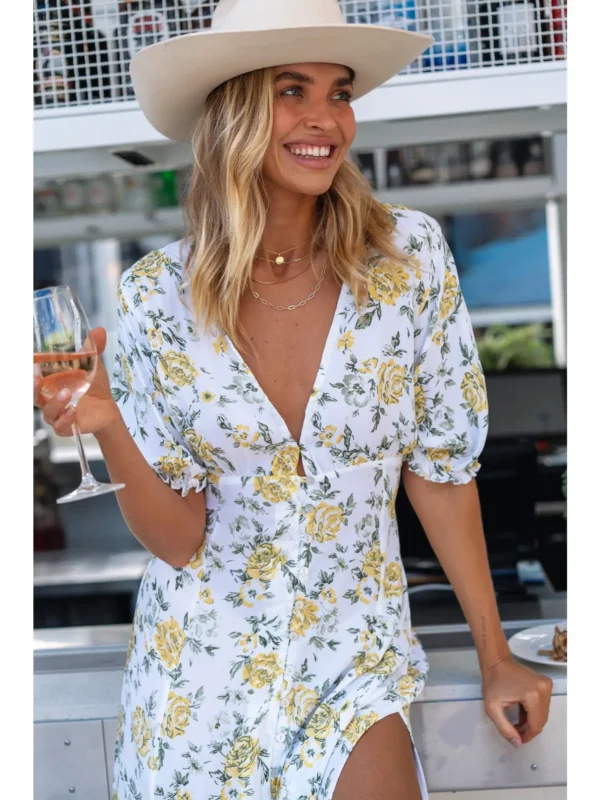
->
[[212, 0, 345, 31]]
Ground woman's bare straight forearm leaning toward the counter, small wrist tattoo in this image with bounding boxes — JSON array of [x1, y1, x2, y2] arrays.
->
[[404, 470, 510, 670]]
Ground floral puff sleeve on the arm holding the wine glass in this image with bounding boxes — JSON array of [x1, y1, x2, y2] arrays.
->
[[111, 272, 208, 497]]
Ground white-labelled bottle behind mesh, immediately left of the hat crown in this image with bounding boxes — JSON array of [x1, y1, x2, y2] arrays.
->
[[115, 0, 188, 98]]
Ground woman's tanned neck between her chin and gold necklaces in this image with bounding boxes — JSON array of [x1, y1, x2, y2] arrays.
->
[[261, 189, 317, 261]]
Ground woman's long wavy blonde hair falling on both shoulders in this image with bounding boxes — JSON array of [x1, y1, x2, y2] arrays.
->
[[184, 68, 406, 357]]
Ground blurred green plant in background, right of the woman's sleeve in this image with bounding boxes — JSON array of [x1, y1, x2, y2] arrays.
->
[[477, 323, 554, 372]]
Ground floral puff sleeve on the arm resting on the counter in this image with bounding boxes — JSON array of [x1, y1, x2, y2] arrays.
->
[[407, 217, 488, 484]]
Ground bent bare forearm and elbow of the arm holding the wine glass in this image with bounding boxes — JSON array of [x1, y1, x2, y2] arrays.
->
[[96, 414, 206, 567]]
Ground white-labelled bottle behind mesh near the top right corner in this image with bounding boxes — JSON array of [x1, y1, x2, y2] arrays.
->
[[478, 0, 548, 65]]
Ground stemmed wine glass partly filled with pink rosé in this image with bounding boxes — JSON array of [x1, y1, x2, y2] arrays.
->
[[33, 286, 125, 503]]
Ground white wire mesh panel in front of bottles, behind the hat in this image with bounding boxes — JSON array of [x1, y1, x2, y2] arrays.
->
[[33, 0, 567, 110]]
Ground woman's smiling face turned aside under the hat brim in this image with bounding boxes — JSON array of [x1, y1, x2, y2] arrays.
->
[[263, 64, 356, 196]]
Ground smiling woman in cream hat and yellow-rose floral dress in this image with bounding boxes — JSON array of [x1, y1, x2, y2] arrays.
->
[[38, 0, 551, 800]]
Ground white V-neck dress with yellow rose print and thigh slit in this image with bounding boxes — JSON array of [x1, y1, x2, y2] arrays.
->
[[113, 207, 487, 800]]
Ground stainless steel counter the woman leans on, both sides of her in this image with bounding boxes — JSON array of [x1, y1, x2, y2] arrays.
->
[[34, 615, 567, 800]]
